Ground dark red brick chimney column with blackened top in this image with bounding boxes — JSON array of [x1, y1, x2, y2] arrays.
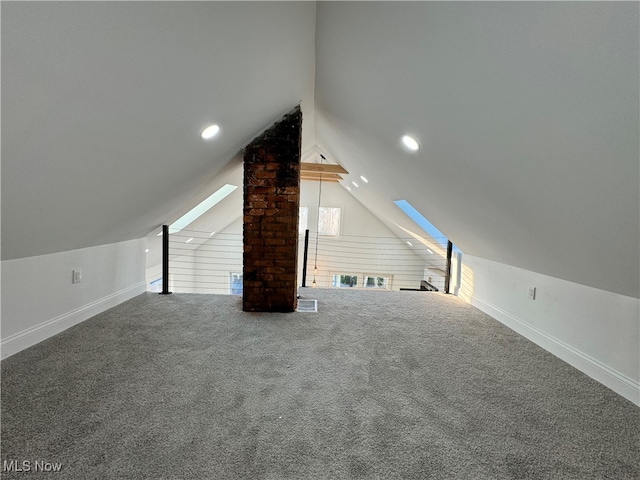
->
[[242, 107, 302, 312]]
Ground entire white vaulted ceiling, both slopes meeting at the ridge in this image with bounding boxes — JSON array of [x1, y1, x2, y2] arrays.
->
[[1, 2, 640, 297]]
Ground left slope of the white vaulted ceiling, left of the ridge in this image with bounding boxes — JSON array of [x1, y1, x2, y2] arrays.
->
[[1, 2, 315, 259]]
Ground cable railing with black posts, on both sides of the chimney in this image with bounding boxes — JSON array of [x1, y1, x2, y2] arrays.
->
[[162, 228, 451, 294]]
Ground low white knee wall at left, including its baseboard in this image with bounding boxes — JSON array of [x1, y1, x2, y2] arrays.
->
[[0, 239, 146, 359]]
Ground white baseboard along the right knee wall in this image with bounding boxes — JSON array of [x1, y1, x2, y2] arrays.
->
[[471, 296, 640, 406]]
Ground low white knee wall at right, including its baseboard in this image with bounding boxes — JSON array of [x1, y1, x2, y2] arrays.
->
[[456, 255, 640, 406]]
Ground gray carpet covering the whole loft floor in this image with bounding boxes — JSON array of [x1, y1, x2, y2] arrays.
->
[[2, 289, 640, 480]]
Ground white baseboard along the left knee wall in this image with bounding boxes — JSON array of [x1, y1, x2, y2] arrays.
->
[[0, 282, 147, 359]]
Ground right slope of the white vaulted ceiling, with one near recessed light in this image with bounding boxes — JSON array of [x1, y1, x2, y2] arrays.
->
[[315, 2, 640, 297]]
